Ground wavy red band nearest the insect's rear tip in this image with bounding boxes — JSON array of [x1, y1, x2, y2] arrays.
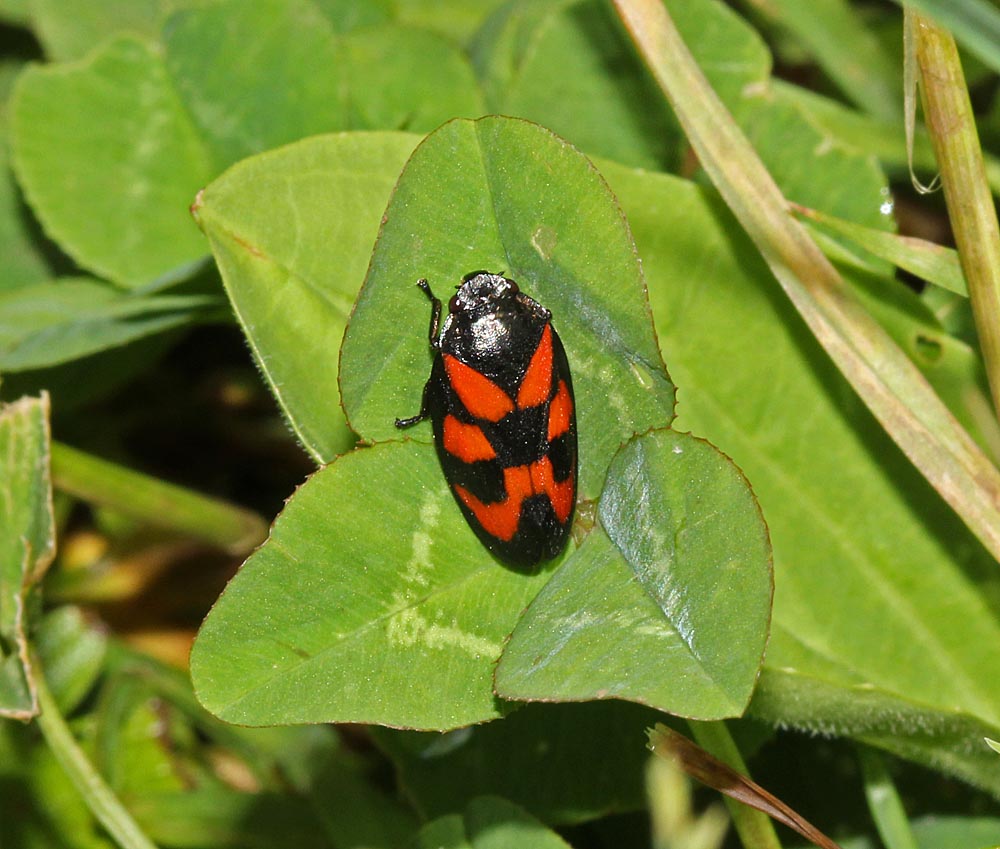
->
[[455, 457, 573, 542]]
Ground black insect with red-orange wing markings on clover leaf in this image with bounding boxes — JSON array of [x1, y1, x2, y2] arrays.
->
[[396, 271, 576, 566]]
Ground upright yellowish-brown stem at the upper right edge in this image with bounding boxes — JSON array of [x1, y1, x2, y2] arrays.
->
[[907, 10, 1000, 416]]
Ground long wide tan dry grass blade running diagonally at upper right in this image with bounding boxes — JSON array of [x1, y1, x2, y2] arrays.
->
[[615, 0, 1000, 560]]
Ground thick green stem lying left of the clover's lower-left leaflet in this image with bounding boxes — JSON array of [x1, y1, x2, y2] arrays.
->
[[52, 442, 267, 554]]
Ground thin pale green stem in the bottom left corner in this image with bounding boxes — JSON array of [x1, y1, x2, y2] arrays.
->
[[32, 654, 156, 849]]
